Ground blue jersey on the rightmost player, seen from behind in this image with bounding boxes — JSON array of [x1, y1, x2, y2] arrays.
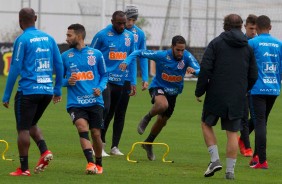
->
[[248, 33, 282, 96]]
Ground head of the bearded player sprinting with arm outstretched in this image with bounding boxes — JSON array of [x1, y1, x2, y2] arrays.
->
[[171, 35, 186, 61]]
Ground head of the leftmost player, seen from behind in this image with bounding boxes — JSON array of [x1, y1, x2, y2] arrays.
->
[[19, 8, 37, 30]]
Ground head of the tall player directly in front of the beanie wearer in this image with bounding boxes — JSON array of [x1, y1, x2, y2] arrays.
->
[[112, 11, 126, 34]]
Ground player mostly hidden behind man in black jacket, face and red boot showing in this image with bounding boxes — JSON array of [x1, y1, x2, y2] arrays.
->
[[238, 14, 257, 157]]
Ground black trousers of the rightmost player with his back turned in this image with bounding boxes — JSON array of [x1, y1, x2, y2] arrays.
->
[[249, 95, 277, 163]]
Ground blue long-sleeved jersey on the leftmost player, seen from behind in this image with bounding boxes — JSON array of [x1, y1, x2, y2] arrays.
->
[[2, 26, 63, 102]]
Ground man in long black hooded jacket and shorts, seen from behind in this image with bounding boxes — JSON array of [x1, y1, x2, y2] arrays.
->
[[195, 14, 258, 179]]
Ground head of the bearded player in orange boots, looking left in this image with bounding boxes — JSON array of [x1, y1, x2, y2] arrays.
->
[[66, 24, 86, 48]]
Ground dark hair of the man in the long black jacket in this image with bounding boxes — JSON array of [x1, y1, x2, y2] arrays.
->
[[223, 14, 243, 31]]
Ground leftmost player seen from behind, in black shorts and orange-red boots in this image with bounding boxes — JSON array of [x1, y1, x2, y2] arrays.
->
[[2, 8, 63, 176]]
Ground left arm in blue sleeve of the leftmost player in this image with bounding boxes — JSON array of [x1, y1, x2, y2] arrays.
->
[[2, 37, 25, 108]]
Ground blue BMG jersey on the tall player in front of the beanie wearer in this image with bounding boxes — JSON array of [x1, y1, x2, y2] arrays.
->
[[91, 25, 137, 85]]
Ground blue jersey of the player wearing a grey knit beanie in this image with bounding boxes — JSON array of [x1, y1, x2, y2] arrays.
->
[[127, 25, 149, 82]]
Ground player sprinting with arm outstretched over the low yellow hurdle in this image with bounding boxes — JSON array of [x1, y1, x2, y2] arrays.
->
[[120, 35, 199, 160]]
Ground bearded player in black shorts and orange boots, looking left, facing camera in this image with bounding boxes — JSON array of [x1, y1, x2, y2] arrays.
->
[[62, 24, 108, 174]]
